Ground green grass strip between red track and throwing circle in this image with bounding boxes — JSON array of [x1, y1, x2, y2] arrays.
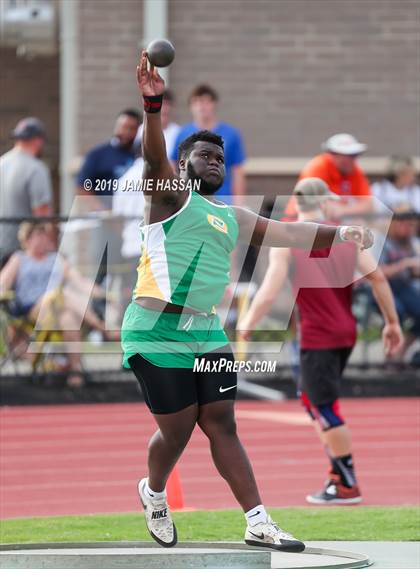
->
[[0, 506, 420, 544]]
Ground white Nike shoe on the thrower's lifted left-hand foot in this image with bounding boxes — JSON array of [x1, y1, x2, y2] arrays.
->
[[138, 478, 178, 547]]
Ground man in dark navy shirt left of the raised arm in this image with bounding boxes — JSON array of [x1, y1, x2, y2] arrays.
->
[[78, 109, 141, 211]]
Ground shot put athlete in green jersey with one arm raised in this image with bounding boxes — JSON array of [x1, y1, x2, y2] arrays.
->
[[122, 52, 373, 552]]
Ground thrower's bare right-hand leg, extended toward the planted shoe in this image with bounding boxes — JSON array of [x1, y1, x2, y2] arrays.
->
[[198, 401, 261, 512]]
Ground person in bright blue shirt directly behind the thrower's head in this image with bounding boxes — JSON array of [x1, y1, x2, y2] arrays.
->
[[170, 85, 245, 205]]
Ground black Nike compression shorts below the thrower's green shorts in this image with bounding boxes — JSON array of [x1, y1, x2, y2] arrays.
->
[[128, 350, 238, 415]]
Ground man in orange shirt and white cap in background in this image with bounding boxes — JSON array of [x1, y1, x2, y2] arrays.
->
[[285, 133, 372, 219]]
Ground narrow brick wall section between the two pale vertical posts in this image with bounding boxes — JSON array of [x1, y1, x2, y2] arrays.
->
[[77, 0, 143, 153]]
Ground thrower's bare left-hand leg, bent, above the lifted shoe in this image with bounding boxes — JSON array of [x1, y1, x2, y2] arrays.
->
[[148, 404, 198, 492]]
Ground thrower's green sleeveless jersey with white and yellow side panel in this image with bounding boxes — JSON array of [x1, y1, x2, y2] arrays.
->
[[133, 191, 239, 312]]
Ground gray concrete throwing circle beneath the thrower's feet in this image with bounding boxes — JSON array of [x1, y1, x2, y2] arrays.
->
[[0, 542, 380, 569]]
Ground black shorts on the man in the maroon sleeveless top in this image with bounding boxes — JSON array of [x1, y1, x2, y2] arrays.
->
[[299, 348, 353, 405]]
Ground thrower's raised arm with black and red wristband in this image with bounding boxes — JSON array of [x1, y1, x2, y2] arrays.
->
[[137, 50, 176, 180]]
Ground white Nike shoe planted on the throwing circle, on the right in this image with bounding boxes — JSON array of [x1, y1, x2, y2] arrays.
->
[[245, 516, 305, 553]]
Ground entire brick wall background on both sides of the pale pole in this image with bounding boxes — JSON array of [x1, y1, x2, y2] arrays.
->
[[79, 0, 420, 156]]
